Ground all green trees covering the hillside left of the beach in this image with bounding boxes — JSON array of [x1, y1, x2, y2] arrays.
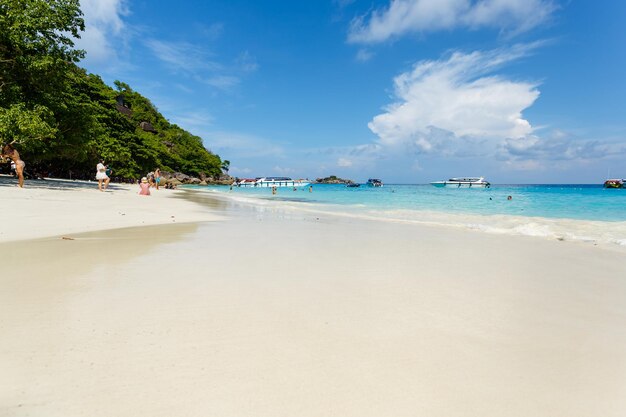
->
[[0, 0, 224, 178]]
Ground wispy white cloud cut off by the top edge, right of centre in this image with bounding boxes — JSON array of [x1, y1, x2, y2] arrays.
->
[[348, 0, 556, 43]]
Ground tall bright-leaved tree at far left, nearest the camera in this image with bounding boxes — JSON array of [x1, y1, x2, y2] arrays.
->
[[0, 0, 84, 148]]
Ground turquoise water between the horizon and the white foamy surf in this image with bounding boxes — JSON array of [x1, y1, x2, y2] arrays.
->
[[204, 184, 626, 221]]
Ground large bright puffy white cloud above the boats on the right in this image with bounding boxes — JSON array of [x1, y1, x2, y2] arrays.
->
[[368, 45, 539, 153]]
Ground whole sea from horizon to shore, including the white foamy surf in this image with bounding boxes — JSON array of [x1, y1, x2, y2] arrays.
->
[[192, 184, 626, 247]]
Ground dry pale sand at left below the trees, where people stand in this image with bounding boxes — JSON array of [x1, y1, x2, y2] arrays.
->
[[0, 176, 223, 242]]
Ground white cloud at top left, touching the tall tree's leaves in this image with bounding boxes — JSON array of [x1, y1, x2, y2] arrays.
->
[[76, 0, 129, 64]]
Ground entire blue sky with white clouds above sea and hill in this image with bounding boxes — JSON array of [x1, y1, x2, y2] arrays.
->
[[76, 0, 626, 184]]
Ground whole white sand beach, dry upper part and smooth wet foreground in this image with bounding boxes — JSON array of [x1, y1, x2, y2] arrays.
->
[[0, 180, 626, 417]]
